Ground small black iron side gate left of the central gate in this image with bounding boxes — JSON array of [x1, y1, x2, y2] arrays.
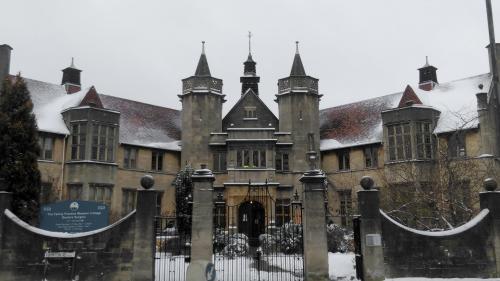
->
[[154, 214, 191, 281]]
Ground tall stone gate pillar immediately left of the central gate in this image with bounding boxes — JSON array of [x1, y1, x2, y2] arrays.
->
[[187, 169, 215, 281]]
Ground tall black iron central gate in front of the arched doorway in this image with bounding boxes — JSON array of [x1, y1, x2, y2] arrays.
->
[[213, 183, 304, 281]]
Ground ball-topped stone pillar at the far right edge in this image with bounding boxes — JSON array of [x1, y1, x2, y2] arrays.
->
[[479, 178, 500, 277]]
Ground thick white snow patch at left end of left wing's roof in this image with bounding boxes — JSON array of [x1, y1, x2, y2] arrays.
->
[[23, 78, 86, 135]]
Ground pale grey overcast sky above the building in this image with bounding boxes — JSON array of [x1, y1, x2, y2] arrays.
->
[[0, 0, 500, 112]]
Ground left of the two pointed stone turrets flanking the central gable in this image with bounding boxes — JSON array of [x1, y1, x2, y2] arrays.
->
[[179, 42, 225, 169]]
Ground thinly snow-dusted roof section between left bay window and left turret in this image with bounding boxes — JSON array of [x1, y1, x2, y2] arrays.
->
[[99, 94, 181, 151]]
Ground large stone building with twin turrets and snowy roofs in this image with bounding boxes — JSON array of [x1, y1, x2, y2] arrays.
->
[[0, 38, 499, 228]]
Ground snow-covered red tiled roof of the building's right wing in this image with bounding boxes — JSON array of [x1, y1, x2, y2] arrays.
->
[[320, 73, 491, 151]]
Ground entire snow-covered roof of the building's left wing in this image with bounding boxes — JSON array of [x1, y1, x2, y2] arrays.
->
[[23, 75, 181, 151]]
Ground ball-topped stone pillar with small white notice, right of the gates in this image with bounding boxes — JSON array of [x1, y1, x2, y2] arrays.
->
[[358, 176, 385, 281]]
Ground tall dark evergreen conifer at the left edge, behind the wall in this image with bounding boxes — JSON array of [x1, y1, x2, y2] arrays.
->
[[0, 75, 40, 222]]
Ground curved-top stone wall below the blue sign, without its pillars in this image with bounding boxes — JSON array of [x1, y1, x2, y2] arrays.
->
[[0, 210, 135, 281]]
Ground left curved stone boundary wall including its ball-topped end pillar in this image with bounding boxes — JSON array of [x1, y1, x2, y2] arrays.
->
[[0, 176, 158, 281]]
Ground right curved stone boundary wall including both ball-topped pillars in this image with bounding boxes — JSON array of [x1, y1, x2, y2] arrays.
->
[[355, 177, 500, 281]]
